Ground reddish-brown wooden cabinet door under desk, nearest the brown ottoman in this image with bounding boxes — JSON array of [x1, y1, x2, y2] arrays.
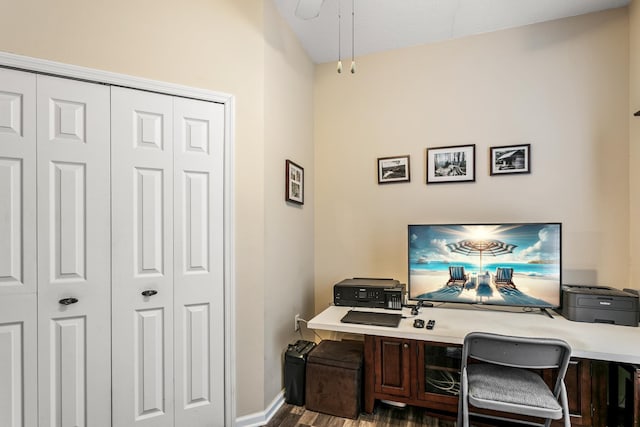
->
[[374, 337, 413, 397]]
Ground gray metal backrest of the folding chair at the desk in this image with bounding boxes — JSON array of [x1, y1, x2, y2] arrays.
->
[[462, 332, 571, 394]]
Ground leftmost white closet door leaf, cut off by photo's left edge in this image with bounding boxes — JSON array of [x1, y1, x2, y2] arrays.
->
[[0, 68, 38, 427]]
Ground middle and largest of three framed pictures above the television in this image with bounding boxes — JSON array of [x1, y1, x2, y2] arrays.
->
[[427, 144, 476, 184]]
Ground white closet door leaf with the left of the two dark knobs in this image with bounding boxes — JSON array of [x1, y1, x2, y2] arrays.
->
[[37, 75, 111, 427]]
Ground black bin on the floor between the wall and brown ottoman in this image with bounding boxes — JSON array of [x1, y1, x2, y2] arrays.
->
[[284, 340, 316, 406]]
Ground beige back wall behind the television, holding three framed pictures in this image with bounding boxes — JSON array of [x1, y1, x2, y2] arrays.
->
[[314, 8, 629, 311]]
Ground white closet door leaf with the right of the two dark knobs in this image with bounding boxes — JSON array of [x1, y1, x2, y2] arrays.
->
[[111, 87, 174, 427]]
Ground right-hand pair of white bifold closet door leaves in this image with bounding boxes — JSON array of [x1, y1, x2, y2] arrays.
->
[[112, 88, 224, 427]]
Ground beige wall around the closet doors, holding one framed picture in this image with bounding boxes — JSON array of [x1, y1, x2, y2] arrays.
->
[[0, 0, 313, 416]]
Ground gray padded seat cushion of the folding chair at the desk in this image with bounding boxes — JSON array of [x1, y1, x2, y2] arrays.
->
[[467, 363, 562, 419]]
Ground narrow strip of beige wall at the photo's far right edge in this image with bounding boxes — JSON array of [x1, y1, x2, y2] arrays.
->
[[628, 0, 640, 289]]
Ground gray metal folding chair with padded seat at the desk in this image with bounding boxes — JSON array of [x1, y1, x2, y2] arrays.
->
[[457, 332, 571, 427]]
